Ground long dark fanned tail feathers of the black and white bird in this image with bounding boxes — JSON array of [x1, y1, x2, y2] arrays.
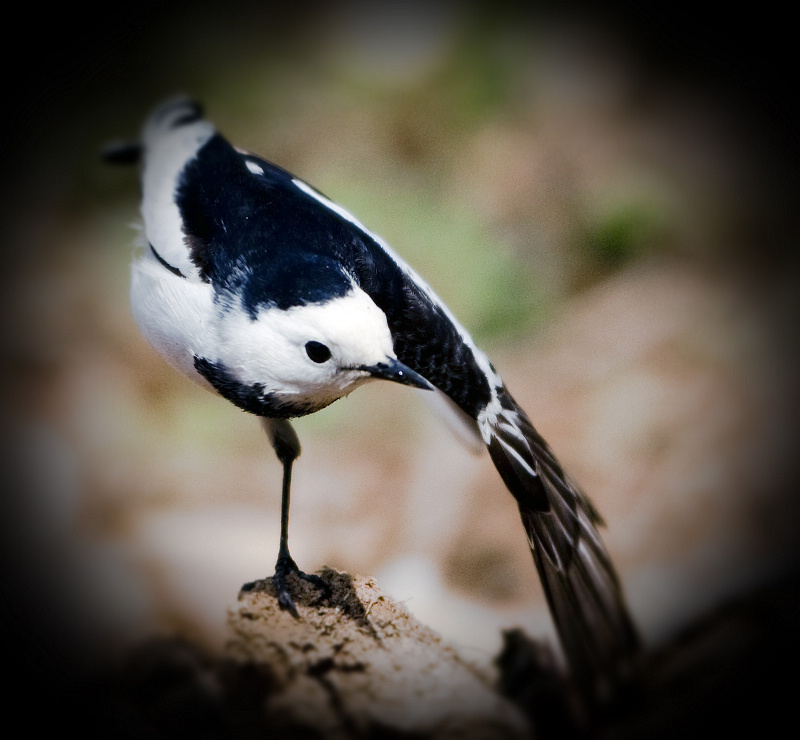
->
[[484, 388, 639, 701]]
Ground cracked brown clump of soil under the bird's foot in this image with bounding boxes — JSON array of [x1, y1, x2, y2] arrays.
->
[[226, 569, 528, 738]]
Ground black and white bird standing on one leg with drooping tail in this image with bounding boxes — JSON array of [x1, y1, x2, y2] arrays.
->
[[105, 96, 640, 695]]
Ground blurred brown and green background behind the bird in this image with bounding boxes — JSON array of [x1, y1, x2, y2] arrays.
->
[[0, 2, 798, 684]]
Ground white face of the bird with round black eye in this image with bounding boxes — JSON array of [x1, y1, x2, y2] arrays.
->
[[218, 286, 395, 405]]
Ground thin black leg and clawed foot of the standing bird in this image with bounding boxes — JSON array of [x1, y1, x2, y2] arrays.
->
[[264, 419, 329, 617]]
